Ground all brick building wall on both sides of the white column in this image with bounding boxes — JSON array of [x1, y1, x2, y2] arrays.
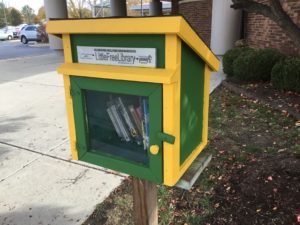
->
[[178, 0, 300, 55]]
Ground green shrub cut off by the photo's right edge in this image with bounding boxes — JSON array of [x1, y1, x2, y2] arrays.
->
[[271, 57, 300, 92]]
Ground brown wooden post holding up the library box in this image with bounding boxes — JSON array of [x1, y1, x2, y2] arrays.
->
[[132, 177, 158, 225]]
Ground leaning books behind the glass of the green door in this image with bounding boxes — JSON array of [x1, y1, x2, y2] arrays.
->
[[106, 97, 149, 150]]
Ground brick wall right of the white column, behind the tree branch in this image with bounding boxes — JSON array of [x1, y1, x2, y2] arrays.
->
[[245, 0, 300, 55]]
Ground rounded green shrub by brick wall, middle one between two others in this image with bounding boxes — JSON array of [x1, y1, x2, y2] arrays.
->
[[233, 49, 284, 81]]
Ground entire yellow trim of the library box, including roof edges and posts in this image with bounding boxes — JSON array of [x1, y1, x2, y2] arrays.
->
[[47, 16, 219, 186]]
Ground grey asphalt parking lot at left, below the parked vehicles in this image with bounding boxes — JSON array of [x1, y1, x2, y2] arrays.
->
[[0, 39, 53, 60]]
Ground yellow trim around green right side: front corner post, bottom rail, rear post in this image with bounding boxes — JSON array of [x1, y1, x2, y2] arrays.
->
[[163, 38, 210, 186]]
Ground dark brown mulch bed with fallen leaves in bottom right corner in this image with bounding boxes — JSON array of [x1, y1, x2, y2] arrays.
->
[[207, 154, 300, 225]]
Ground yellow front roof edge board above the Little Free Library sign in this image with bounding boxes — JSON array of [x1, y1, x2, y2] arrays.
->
[[47, 16, 181, 34]]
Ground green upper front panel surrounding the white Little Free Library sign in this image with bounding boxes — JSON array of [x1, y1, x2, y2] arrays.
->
[[71, 34, 165, 68]]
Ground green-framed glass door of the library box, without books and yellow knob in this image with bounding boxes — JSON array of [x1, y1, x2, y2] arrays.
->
[[71, 76, 163, 184]]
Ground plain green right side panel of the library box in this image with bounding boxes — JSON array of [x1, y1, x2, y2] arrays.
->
[[180, 42, 205, 164]]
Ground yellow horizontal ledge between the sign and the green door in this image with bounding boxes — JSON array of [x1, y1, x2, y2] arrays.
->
[[57, 63, 178, 84]]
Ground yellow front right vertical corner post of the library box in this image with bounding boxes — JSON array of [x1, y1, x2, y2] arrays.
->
[[163, 34, 181, 186]]
